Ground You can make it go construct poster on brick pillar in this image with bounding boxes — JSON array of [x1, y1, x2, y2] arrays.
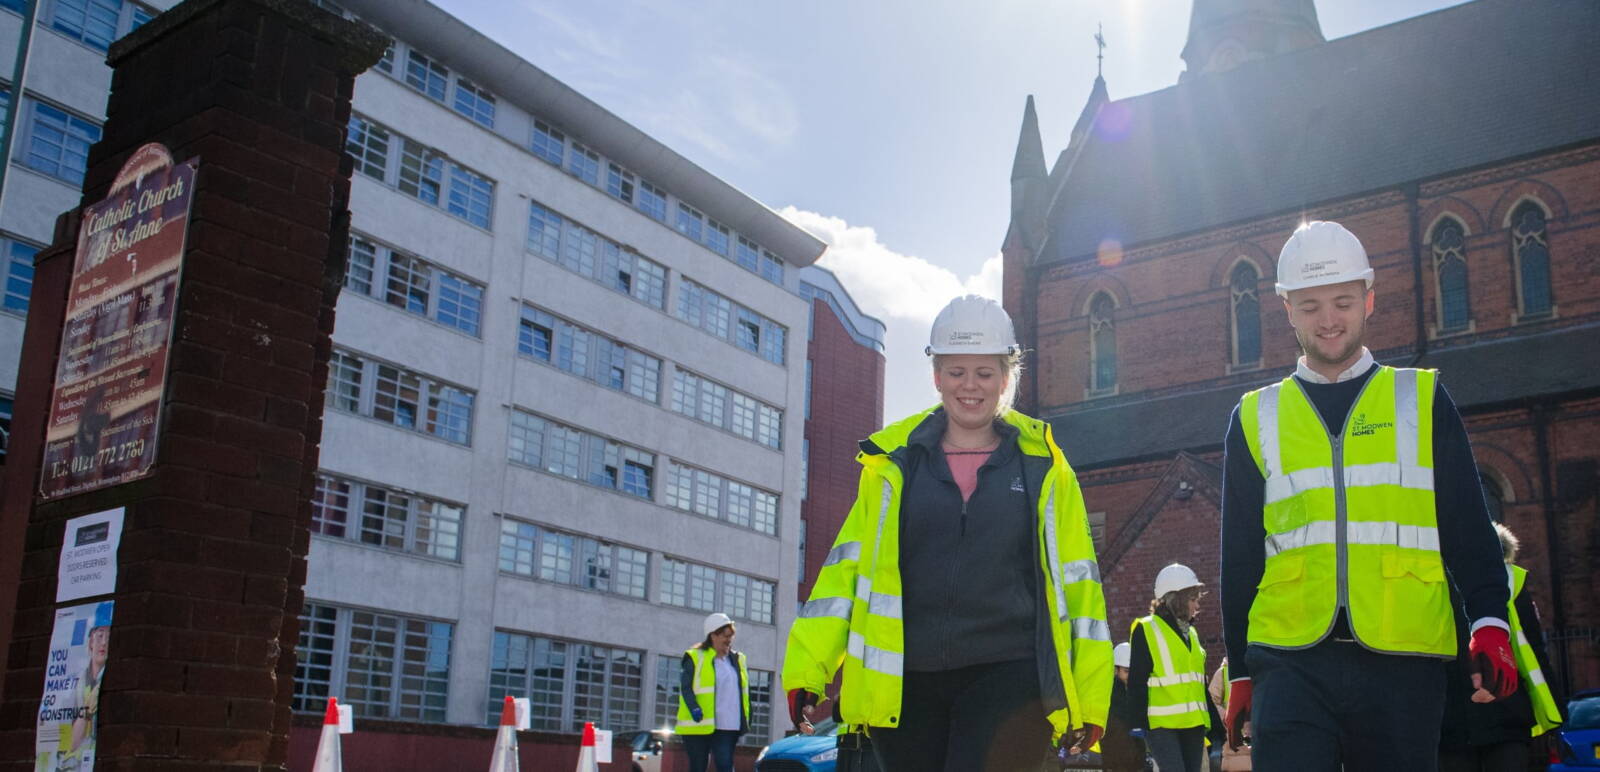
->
[[34, 601, 112, 772]]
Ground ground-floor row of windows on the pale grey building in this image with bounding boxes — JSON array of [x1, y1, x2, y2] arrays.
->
[[293, 602, 773, 745]]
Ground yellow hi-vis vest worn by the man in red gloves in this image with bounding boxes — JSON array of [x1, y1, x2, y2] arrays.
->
[[1238, 367, 1456, 657]]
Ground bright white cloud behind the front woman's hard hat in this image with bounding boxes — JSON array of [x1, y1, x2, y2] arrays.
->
[[778, 207, 1002, 421]]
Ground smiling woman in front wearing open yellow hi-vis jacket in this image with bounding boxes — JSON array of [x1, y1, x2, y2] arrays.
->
[[782, 295, 1112, 772]]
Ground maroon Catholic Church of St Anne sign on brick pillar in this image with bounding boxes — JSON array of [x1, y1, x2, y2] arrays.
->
[[38, 143, 198, 500]]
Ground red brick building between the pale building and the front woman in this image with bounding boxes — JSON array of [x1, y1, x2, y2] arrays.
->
[[800, 300, 889, 601]]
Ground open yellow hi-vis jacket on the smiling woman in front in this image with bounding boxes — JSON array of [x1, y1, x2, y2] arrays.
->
[[782, 410, 1112, 737]]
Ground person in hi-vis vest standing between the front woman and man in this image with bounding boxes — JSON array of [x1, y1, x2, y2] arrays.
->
[[1128, 562, 1222, 772]]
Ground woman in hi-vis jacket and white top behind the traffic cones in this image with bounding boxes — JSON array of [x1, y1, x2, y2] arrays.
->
[[674, 613, 750, 772]]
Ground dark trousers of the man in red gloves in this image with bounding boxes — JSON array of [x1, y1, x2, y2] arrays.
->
[[1245, 639, 1445, 772]]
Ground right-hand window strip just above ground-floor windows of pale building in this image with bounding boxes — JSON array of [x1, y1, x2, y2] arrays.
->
[[499, 517, 778, 625]]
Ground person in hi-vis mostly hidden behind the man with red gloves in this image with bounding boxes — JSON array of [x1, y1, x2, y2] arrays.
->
[[1438, 522, 1562, 772]]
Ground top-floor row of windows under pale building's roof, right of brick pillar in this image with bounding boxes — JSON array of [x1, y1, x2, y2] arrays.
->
[[358, 27, 784, 287]]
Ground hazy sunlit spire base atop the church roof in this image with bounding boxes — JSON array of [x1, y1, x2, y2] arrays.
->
[[1179, 0, 1326, 80]]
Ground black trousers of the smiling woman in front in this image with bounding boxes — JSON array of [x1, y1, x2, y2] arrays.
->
[[872, 660, 1053, 772]]
